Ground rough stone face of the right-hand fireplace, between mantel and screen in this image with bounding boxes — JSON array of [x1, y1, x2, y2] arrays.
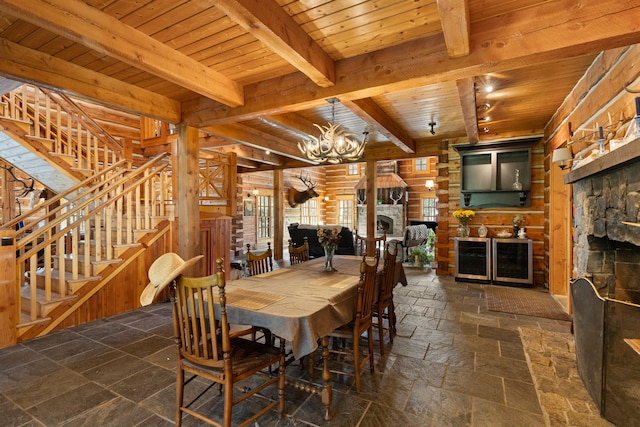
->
[[574, 161, 640, 303]]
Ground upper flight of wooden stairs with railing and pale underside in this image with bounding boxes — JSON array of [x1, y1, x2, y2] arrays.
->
[[0, 84, 123, 193]]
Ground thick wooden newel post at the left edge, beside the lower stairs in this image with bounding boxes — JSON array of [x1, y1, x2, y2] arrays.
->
[[0, 228, 19, 348]]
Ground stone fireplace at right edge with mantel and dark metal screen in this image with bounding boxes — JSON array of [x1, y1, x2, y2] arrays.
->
[[565, 145, 640, 425]]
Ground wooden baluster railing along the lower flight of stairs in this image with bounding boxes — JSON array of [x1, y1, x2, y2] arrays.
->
[[16, 154, 172, 321]]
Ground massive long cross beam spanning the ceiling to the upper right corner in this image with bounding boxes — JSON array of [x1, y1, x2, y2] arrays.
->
[[182, 0, 640, 127]]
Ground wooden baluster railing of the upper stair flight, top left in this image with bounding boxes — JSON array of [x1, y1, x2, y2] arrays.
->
[[2, 84, 123, 171]]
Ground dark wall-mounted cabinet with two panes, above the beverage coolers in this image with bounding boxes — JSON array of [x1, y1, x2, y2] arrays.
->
[[455, 139, 538, 208]]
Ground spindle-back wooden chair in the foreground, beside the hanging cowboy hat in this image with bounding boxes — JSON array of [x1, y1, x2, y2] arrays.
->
[[171, 259, 285, 427]]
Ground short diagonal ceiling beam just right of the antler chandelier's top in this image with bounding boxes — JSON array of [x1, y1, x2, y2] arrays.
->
[[342, 98, 416, 153]]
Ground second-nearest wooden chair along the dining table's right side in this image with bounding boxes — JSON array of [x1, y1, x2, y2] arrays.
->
[[373, 243, 398, 355]]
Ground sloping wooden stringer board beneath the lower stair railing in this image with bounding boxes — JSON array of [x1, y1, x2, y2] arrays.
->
[[18, 219, 175, 341]]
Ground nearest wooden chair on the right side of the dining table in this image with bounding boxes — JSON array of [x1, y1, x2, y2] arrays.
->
[[309, 251, 380, 393]]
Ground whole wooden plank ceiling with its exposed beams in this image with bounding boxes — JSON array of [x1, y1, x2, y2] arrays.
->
[[0, 0, 640, 170]]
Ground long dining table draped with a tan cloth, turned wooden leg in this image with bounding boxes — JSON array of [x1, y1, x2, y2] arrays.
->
[[225, 255, 382, 420]]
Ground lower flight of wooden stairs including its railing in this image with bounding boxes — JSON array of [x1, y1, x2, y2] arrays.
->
[[4, 154, 173, 339]]
